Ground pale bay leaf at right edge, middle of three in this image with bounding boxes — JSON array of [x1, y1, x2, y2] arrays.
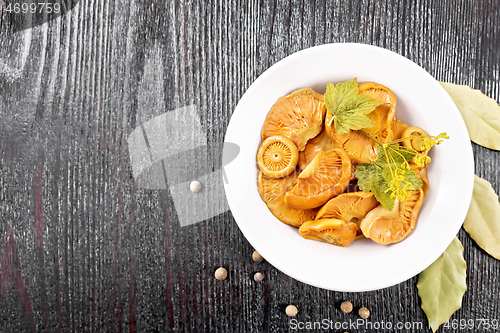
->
[[464, 175, 500, 260]]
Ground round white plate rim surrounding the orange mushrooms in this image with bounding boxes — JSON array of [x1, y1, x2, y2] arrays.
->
[[224, 44, 474, 292]]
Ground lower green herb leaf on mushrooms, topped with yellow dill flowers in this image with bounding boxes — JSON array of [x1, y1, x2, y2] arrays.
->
[[354, 144, 422, 210]]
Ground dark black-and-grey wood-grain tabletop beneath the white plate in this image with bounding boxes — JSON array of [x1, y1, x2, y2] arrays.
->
[[0, 0, 500, 332]]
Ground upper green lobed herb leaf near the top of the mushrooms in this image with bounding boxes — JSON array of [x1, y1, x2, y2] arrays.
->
[[325, 78, 383, 134]]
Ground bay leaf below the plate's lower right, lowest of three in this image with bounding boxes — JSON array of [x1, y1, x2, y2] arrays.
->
[[417, 237, 467, 332]]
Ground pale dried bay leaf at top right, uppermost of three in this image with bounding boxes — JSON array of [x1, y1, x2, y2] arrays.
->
[[440, 82, 500, 150]]
